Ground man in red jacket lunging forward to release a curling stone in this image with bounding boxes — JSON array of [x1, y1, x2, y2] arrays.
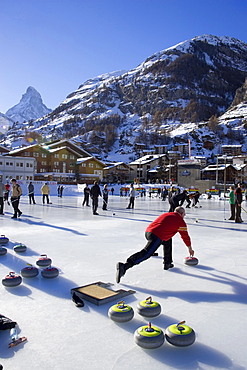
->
[[116, 207, 194, 283]]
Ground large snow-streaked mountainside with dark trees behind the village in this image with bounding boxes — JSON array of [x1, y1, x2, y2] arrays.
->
[[2, 35, 247, 161]]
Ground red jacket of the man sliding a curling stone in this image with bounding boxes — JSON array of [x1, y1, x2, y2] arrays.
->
[[146, 212, 191, 247]]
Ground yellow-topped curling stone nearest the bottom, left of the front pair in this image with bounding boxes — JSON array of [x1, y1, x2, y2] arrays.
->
[[134, 323, 165, 349]]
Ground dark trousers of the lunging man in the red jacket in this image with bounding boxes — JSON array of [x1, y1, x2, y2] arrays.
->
[[126, 232, 172, 268]]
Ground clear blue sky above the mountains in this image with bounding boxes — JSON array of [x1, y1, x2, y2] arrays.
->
[[0, 0, 247, 113]]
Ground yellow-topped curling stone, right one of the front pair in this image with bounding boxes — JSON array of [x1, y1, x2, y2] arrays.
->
[[165, 321, 196, 347]]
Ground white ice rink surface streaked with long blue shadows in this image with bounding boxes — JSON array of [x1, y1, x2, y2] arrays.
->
[[0, 195, 247, 370]]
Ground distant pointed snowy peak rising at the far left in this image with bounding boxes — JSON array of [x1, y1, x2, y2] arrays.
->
[[5, 86, 52, 123]]
